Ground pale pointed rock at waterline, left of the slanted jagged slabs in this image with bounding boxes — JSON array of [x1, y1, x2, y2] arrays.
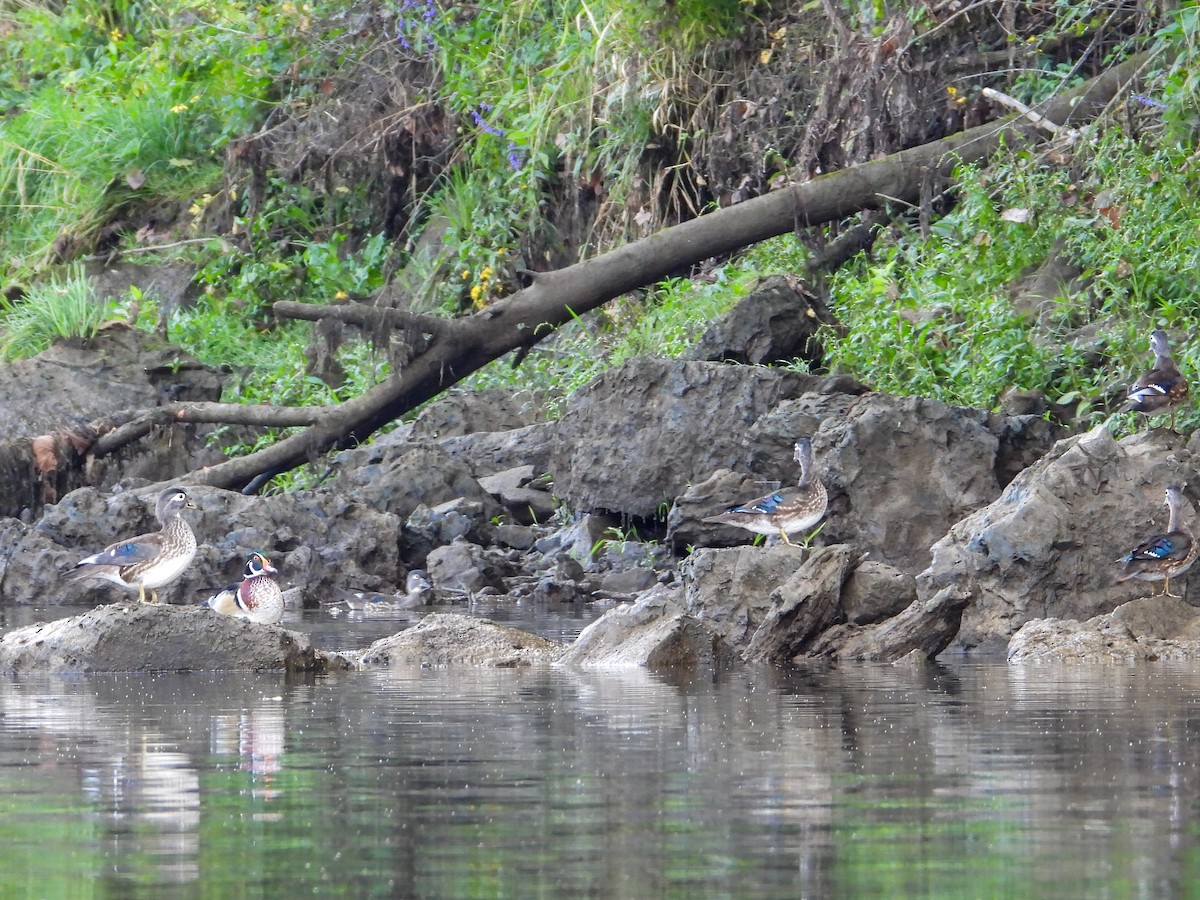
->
[[558, 588, 737, 673]]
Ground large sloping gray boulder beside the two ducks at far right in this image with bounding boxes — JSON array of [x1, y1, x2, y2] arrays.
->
[[917, 426, 1195, 650]]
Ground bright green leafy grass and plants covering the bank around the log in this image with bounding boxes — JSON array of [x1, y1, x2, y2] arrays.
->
[[0, 0, 1200, 482]]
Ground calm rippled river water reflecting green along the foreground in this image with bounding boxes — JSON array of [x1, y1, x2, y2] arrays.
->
[[0, 614, 1200, 898]]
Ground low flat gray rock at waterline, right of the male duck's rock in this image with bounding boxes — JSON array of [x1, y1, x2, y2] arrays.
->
[[359, 613, 564, 668]]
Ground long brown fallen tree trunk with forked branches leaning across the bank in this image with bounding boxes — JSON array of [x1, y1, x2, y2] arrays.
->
[[21, 58, 1145, 490]]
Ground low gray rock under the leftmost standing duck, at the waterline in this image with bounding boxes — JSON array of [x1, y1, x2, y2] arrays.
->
[[0, 604, 347, 673]]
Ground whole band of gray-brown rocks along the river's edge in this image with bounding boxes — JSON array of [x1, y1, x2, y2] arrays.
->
[[0, 340, 1200, 672]]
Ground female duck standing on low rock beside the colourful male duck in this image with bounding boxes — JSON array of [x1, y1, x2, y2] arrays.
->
[[67, 487, 197, 604]]
